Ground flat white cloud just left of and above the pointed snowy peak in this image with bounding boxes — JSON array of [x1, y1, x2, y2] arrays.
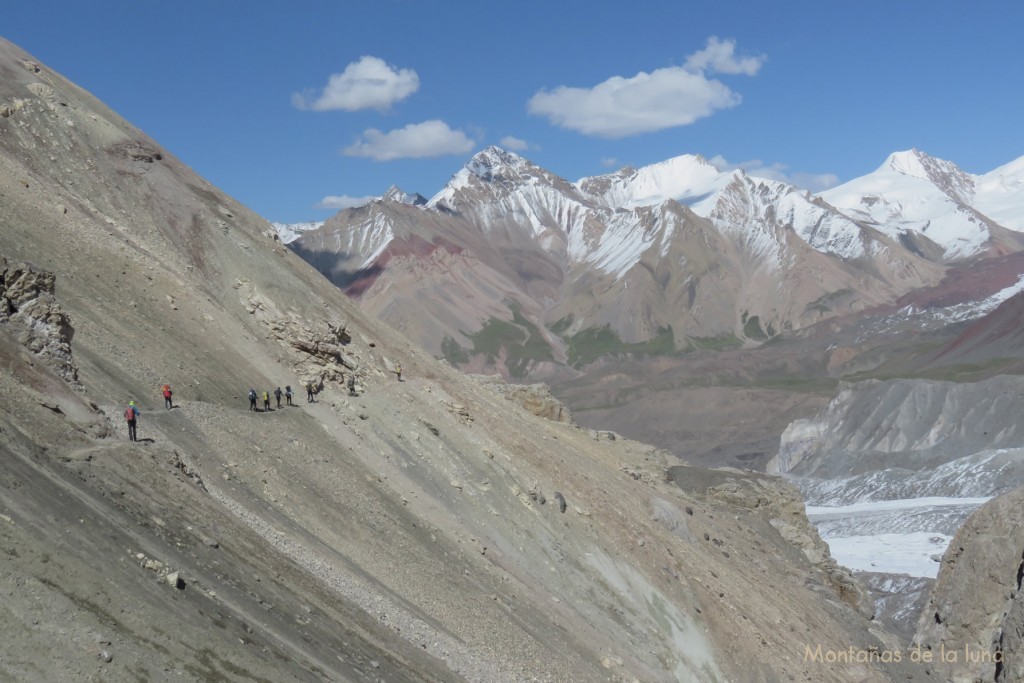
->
[[342, 120, 476, 161]]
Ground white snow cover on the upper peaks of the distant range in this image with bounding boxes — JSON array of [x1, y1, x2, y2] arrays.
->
[[274, 146, 1024, 276]]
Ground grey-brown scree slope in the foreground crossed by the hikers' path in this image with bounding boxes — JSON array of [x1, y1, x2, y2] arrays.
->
[[0, 41, 937, 682]]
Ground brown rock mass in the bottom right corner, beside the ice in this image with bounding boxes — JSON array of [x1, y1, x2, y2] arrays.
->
[[914, 488, 1024, 683]]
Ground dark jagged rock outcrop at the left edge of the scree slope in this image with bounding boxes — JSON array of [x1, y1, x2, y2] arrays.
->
[[0, 257, 78, 383]]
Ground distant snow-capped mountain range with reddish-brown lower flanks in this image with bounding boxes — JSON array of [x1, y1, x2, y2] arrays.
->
[[290, 147, 1024, 378]]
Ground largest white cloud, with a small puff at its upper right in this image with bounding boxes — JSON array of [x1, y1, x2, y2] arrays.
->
[[526, 37, 764, 138]]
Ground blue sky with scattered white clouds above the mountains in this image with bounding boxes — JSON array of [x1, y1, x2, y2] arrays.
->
[[8, 0, 1024, 222]]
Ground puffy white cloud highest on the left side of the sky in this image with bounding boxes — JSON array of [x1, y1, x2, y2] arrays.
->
[[292, 55, 420, 112]]
